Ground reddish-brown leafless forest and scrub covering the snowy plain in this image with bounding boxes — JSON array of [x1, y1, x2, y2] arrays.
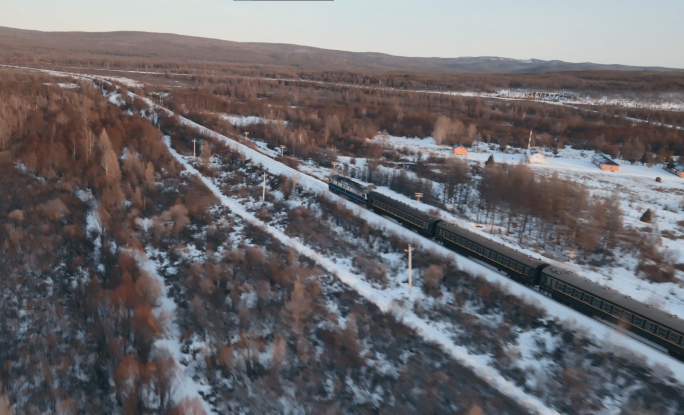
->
[[0, 44, 684, 415]]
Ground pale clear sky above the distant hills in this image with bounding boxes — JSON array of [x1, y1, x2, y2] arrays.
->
[[0, 0, 684, 68]]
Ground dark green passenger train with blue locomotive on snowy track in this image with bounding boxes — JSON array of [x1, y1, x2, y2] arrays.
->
[[328, 175, 684, 361]]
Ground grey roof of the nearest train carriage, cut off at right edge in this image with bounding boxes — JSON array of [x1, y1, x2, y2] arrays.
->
[[543, 267, 684, 333]]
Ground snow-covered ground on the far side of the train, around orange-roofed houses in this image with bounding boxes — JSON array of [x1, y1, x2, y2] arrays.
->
[[372, 136, 684, 316]]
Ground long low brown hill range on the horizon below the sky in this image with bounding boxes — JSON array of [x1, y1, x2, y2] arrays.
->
[[0, 27, 674, 73]]
